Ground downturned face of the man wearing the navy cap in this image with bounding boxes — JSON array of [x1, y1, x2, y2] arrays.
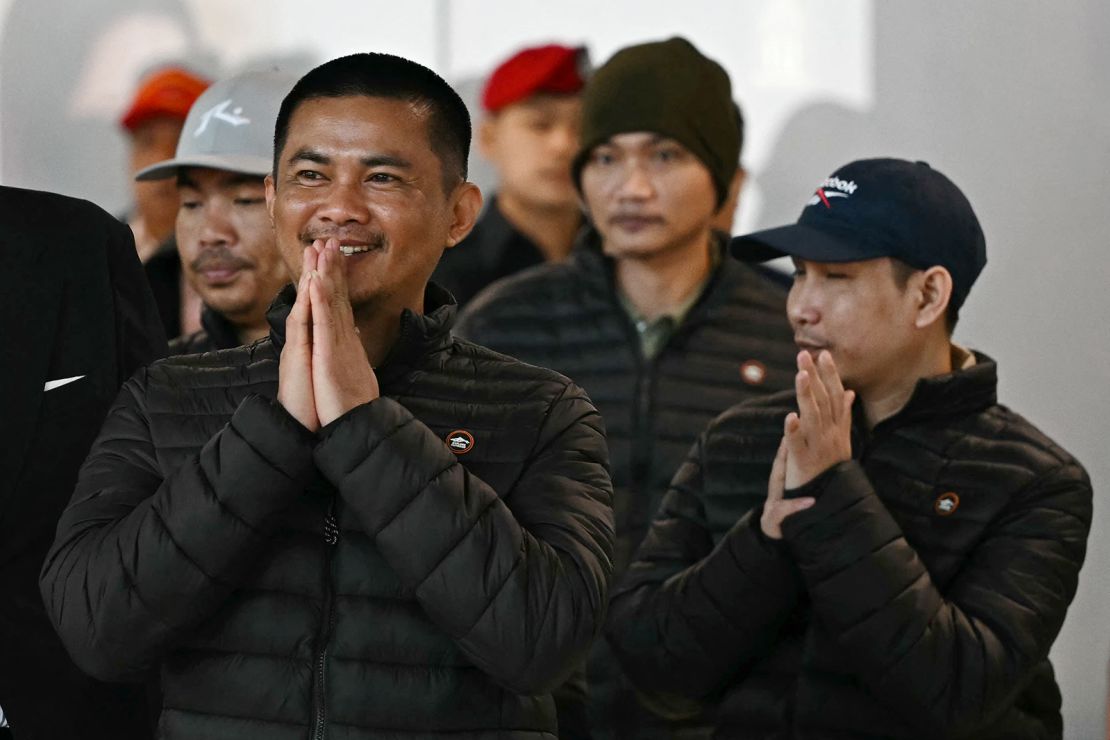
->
[[786, 257, 922, 396]]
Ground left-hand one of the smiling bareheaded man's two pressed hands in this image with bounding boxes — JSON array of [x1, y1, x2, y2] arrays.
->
[[278, 246, 320, 432]]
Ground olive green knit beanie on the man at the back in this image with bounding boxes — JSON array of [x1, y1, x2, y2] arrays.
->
[[573, 37, 740, 205]]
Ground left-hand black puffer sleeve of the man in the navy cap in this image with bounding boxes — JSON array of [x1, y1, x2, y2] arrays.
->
[[606, 437, 799, 698]]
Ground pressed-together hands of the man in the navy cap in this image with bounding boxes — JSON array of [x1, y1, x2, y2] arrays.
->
[[759, 351, 856, 539]]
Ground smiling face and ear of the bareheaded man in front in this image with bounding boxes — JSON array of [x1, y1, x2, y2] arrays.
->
[[266, 95, 481, 311]]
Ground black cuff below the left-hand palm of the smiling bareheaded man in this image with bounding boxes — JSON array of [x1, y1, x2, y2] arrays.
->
[[231, 393, 316, 484]]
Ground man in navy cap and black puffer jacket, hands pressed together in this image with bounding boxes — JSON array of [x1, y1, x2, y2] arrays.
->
[[607, 159, 1091, 740]]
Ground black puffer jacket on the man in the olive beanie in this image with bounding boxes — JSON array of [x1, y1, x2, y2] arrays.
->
[[457, 234, 797, 739]]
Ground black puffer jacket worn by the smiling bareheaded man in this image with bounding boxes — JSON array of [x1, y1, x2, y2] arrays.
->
[[41, 286, 613, 740]]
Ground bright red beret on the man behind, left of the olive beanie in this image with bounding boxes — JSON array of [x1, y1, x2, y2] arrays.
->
[[482, 43, 589, 113]]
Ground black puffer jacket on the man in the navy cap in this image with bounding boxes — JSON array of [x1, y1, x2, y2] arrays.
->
[[607, 355, 1091, 740]]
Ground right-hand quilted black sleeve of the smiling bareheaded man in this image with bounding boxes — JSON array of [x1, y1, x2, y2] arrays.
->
[[315, 385, 614, 695]]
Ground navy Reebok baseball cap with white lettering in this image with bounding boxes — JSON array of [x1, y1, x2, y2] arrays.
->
[[730, 159, 987, 307]]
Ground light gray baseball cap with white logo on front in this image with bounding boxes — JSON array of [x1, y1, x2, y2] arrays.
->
[[135, 72, 297, 180]]
